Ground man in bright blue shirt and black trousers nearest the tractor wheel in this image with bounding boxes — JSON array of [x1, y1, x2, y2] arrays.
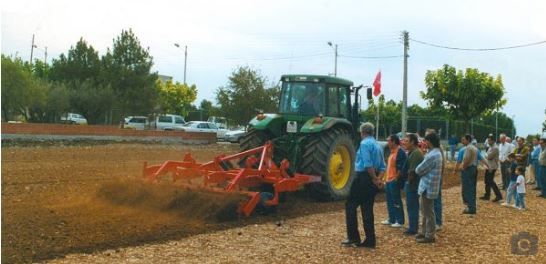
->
[[341, 122, 385, 248]]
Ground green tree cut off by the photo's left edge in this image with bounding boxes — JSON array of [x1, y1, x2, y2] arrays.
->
[[1, 54, 33, 121]]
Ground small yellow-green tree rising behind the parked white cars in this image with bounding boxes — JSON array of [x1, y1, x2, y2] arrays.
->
[[157, 80, 197, 116]]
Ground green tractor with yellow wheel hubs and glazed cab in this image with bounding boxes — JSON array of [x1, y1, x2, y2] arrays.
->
[[241, 75, 370, 201]]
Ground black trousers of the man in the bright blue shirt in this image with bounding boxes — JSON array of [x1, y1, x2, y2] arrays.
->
[[345, 172, 377, 242]]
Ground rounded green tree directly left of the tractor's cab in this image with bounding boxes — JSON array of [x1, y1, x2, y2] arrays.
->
[[216, 67, 280, 125]]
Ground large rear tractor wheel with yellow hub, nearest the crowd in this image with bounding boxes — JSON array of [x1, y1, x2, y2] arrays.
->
[[300, 128, 355, 201]]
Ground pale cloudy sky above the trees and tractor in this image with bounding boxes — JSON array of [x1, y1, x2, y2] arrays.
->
[[1, 0, 546, 135]]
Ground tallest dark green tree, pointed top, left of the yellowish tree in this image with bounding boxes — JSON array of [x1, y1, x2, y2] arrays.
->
[[101, 29, 158, 119]]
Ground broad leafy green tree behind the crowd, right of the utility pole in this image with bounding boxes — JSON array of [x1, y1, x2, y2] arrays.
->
[[421, 64, 506, 132]]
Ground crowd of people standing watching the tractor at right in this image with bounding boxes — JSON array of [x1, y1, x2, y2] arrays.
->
[[342, 123, 546, 248]]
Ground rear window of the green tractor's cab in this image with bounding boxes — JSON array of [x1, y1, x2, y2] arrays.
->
[[279, 82, 324, 115]]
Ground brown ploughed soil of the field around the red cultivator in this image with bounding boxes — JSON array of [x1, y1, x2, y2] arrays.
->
[[2, 144, 459, 263]]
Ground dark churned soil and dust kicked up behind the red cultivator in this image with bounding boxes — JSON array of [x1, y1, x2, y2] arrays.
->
[[97, 180, 248, 223]]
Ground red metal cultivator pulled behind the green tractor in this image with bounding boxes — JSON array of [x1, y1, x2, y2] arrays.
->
[[143, 142, 321, 216]]
